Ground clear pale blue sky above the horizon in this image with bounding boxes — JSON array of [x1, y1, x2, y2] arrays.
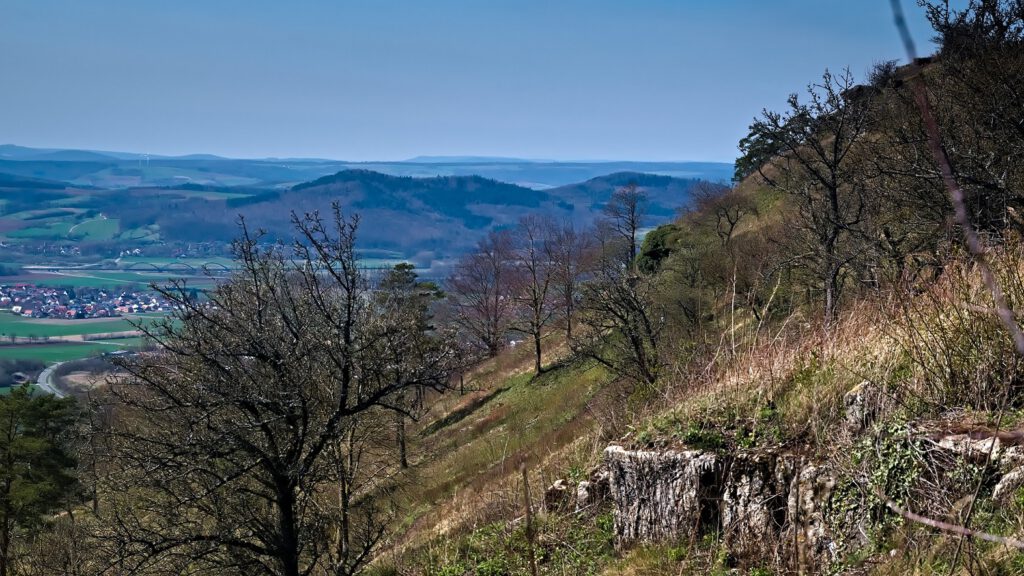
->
[[0, 0, 950, 161]]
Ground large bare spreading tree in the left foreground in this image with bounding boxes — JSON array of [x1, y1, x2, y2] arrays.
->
[[98, 207, 452, 576]]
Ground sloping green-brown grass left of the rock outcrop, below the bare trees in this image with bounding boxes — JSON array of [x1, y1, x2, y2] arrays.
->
[[382, 337, 622, 561]]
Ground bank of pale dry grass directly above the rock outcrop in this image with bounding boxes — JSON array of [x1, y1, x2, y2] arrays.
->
[[632, 295, 899, 448]]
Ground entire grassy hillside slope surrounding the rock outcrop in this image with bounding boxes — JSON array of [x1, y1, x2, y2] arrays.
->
[[389, 169, 1024, 575]]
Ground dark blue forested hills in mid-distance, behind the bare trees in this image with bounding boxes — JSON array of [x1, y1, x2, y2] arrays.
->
[[226, 170, 698, 254]]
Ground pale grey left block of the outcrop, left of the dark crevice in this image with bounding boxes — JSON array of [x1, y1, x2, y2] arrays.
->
[[604, 446, 725, 546]]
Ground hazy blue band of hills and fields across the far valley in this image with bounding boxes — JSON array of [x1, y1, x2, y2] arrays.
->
[[0, 165, 698, 269]]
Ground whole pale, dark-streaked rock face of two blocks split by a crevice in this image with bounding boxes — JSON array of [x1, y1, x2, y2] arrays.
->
[[604, 446, 851, 568]]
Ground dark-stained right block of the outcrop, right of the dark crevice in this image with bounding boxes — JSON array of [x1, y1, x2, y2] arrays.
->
[[722, 452, 795, 557]]
